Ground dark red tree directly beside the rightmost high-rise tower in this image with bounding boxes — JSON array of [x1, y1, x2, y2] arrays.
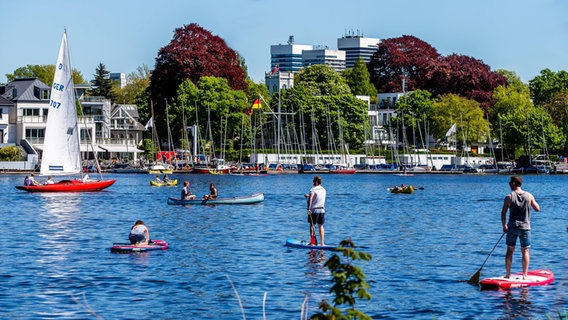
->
[[367, 35, 440, 92]]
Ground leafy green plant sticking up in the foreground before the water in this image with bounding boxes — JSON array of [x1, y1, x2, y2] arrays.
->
[[310, 239, 372, 320]]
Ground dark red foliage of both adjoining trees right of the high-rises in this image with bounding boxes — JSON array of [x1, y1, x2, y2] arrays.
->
[[367, 36, 506, 111]]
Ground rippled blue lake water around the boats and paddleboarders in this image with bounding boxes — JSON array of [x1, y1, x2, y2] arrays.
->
[[0, 174, 568, 319]]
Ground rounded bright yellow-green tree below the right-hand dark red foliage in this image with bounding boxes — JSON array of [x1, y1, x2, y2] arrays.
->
[[430, 94, 488, 145]]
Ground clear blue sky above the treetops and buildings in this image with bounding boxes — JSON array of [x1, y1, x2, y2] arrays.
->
[[0, 0, 568, 83]]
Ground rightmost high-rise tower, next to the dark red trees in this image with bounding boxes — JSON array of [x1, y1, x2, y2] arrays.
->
[[337, 35, 381, 68]]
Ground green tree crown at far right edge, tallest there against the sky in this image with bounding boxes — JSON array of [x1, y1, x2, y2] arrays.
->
[[529, 69, 568, 105]]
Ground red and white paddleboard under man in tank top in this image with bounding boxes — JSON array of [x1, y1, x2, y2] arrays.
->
[[479, 269, 554, 289]]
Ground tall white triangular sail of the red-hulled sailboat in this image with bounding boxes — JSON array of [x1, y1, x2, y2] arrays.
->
[[40, 32, 81, 175]]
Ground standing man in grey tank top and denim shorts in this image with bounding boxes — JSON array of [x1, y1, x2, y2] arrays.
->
[[501, 176, 540, 278]]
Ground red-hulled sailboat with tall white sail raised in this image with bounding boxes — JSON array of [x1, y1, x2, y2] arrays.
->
[[16, 32, 116, 192]]
